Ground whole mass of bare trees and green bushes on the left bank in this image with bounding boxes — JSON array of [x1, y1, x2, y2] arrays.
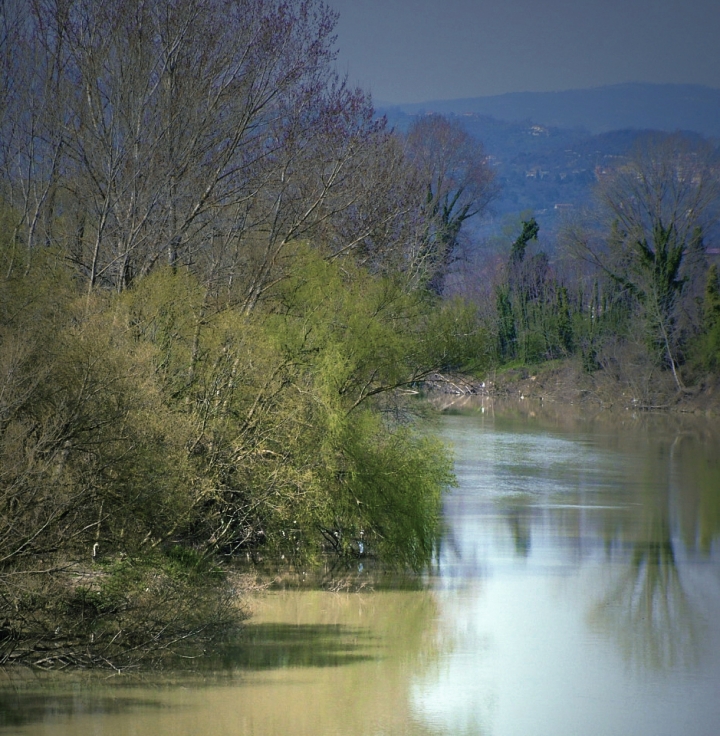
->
[[0, 0, 466, 664]]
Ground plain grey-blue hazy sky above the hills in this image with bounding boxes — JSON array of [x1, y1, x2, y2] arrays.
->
[[326, 0, 720, 103]]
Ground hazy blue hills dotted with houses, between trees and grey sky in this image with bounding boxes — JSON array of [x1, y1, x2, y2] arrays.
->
[[378, 84, 720, 240]]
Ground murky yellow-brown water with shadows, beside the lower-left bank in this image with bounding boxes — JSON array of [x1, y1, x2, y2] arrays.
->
[[0, 588, 448, 736]]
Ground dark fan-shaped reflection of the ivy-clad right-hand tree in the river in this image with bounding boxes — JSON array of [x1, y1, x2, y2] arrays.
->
[[590, 423, 720, 670]]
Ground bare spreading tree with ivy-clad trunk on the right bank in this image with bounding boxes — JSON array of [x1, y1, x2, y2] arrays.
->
[[573, 134, 718, 389]]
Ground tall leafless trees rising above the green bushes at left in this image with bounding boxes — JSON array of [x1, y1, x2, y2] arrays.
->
[[0, 0, 414, 304]]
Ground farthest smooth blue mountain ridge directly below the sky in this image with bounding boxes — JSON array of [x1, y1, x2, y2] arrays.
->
[[386, 83, 720, 138]]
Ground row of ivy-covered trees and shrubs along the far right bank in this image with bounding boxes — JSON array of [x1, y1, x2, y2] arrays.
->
[[464, 134, 720, 406]]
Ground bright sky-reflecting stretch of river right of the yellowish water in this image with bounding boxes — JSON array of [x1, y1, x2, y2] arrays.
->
[[415, 402, 720, 736]]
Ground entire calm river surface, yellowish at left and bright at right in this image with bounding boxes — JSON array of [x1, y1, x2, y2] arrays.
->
[[0, 402, 720, 736]]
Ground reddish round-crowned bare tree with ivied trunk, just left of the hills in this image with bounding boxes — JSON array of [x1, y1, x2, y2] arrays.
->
[[406, 115, 496, 293]]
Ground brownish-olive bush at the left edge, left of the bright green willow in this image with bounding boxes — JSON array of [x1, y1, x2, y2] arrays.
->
[[0, 264, 194, 560]]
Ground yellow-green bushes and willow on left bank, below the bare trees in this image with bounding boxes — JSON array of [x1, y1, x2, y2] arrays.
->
[[0, 237, 458, 661]]
